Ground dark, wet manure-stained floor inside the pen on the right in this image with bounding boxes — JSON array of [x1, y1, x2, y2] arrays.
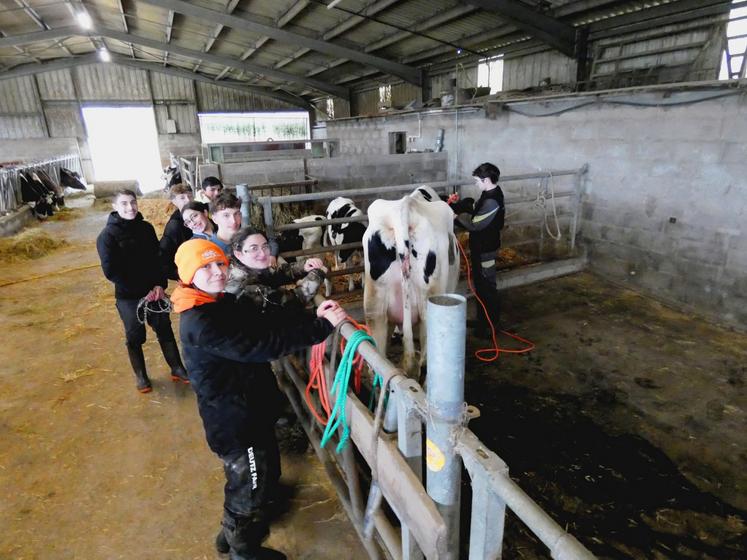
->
[[466, 273, 747, 560]]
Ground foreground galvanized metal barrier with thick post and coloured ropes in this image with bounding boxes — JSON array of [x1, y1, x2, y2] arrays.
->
[[276, 294, 594, 560]]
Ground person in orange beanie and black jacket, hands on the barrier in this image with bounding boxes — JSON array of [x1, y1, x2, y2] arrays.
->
[[172, 239, 346, 560]]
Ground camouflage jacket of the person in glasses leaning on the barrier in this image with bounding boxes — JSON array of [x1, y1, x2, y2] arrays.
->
[[226, 257, 326, 311]]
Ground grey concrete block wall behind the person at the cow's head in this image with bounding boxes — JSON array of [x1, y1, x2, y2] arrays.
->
[[327, 88, 747, 329]]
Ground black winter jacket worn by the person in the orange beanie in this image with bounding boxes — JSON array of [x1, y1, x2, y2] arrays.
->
[[179, 294, 333, 457]]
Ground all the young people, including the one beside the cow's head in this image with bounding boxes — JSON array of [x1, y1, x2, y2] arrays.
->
[[96, 163, 505, 560]]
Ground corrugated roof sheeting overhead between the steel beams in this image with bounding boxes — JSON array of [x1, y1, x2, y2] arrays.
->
[[0, 0, 729, 104]]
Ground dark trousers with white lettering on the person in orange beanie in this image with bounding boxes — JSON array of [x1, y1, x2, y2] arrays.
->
[[221, 428, 280, 557]]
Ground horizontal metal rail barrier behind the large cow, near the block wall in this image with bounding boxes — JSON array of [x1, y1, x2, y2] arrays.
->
[[254, 165, 588, 286]]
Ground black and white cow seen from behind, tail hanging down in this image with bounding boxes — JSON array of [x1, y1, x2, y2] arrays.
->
[[363, 189, 459, 375]]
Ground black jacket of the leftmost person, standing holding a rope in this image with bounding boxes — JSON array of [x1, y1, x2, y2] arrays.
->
[[96, 212, 166, 299]]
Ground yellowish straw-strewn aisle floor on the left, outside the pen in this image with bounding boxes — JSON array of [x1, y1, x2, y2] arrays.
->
[[0, 202, 365, 560]]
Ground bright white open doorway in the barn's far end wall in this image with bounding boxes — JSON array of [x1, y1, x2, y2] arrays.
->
[[83, 107, 163, 193]]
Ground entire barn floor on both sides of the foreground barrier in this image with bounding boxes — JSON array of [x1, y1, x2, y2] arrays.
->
[[0, 199, 747, 560]]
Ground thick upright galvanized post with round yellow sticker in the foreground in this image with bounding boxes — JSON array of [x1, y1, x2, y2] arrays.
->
[[426, 294, 467, 560]]
